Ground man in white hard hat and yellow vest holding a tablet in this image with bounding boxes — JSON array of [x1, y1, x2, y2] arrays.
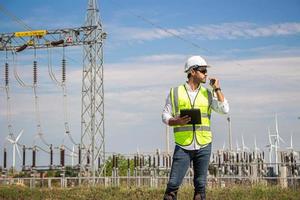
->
[[162, 56, 229, 200]]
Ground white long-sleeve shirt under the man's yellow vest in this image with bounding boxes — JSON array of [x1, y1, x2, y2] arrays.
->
[[162, 83, 229, 150]]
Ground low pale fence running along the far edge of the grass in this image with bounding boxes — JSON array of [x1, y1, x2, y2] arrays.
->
[[0, 176, 300, 190]]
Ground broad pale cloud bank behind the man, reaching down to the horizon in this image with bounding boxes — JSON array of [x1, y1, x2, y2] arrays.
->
[[1, 54, 300, 155]]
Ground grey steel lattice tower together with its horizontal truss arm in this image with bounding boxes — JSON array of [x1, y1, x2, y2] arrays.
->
[[0, 0, 106, 180]]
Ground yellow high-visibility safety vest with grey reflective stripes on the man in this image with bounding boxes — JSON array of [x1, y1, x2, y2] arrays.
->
[[170, 85, 212, 146]]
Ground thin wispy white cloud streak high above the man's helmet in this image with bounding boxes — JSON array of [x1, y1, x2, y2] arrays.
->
[[108, 22, 300, 41]]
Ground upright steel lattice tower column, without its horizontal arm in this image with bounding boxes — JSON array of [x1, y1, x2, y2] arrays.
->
[[80, 0, 106, 177]]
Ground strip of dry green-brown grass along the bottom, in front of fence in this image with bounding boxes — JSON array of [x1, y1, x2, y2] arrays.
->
[[0, 186, 300, 200]]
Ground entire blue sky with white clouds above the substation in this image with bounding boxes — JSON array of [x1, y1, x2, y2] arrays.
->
[[0, 0, 300, 167]]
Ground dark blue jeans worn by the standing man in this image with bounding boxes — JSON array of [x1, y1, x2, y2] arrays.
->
[[165, 143, 212, 199]]
